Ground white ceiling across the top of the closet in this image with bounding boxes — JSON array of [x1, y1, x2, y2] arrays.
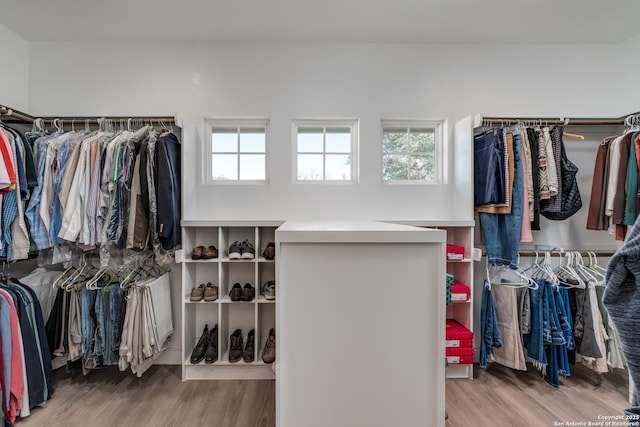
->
[[0, 0, 640, 43]]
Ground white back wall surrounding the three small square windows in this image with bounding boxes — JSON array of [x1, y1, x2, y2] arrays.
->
[[29, 42, 621, 224]]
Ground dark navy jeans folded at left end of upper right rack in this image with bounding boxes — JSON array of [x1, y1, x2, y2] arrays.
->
[[474, 129, 507, 206]]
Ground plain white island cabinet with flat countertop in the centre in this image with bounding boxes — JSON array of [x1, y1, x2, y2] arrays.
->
[[275, 221, 446, 427]]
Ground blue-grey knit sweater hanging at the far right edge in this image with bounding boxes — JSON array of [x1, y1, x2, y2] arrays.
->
[[603, 217, 640, 402]]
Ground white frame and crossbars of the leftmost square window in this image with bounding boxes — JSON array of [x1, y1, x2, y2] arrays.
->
[[202, 117, 271, 185]]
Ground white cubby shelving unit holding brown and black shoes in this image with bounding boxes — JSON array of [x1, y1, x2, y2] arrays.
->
[[182, 221, 281, 380]]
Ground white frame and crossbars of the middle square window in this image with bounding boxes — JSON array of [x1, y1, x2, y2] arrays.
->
[[291, 118, 359, 185]]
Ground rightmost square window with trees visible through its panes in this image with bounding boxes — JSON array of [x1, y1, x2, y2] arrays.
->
[[382, 120, 442, 183]]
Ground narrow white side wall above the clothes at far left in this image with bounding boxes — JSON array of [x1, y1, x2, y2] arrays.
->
[[0, 24, 29, 112]]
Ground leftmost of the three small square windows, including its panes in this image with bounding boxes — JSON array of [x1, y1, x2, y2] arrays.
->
[[208, 120, 268, 182]]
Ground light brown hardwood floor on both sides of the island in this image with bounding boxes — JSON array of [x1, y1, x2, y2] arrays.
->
[[16, 365, 628, 427]]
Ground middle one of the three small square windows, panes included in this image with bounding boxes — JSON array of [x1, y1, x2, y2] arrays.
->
[[294, 120, 357, 182]]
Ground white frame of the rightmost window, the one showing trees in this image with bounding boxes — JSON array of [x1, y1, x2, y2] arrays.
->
[[379, 119, 447, 185]]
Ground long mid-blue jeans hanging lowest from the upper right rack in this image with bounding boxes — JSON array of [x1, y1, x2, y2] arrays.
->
[[480, 135, 524, 269]]
